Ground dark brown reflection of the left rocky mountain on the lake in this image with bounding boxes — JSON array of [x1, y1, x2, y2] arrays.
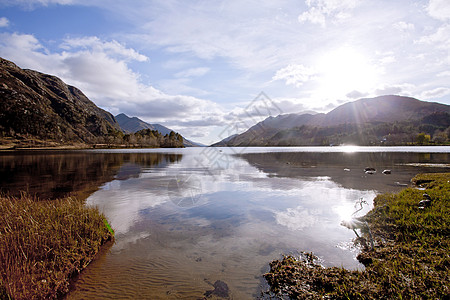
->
[[0, 151, 182, 199]]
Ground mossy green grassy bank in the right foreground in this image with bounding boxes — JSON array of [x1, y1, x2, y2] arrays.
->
[[264, 173, 450, 299]]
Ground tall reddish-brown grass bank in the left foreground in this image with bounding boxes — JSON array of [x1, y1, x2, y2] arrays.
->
[[0, 196, 113, 299]]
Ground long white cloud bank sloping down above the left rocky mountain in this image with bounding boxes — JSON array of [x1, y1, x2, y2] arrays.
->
[[0, 33, 222, 138]]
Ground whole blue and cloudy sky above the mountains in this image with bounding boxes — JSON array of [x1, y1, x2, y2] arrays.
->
[[0, 0, 450, 144]]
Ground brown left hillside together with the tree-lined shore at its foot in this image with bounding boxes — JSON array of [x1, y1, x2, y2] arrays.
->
[[0, 58, 183, 148]]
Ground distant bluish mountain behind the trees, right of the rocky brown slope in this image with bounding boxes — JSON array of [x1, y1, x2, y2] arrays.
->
[[115, 113, 203, 147]]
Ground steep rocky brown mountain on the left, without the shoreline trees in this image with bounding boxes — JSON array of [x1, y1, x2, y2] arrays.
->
[[0, 58, 120, 144]]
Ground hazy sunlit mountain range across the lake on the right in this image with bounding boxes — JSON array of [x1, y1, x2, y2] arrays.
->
[[213, 95, 450, 146]]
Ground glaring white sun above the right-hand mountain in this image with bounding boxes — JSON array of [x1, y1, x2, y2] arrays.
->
[[317, 46, 380, 98]]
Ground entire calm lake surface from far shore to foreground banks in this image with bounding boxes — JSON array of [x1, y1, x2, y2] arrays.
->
[[0, 147, 450, 299]]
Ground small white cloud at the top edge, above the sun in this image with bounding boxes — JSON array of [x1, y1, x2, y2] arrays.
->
[[298, 0, 359, 27]]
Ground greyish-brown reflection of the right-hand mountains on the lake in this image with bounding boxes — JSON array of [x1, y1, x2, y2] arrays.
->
[[238, 151, 450, 192]]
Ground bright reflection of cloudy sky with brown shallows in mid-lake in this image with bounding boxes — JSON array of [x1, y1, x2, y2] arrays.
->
[[67, 150, 398, 299]]
